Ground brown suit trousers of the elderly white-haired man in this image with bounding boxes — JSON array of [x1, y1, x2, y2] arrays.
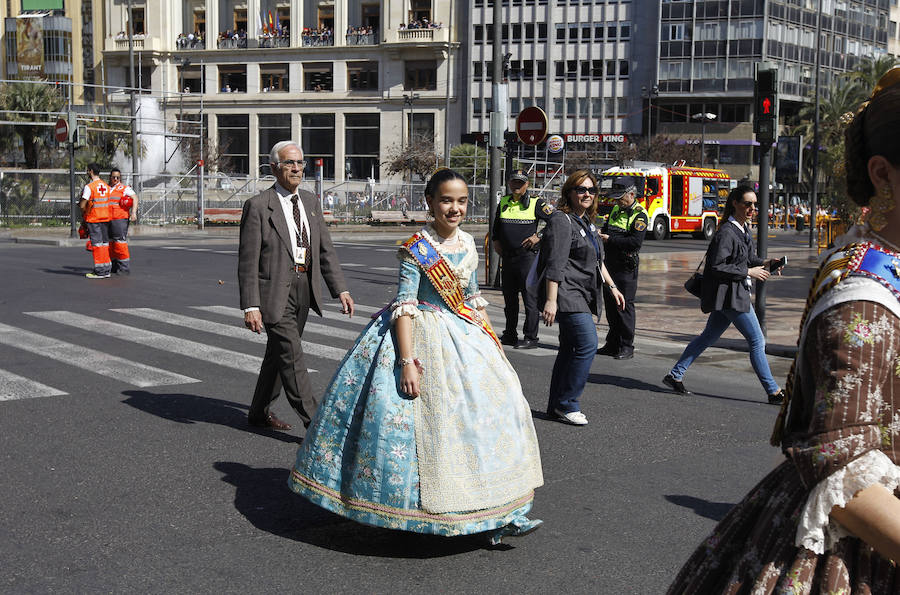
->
[[247, 273, 318, 427]]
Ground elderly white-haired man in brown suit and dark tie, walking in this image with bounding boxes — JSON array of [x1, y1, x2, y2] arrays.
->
[[238, 141, 353, 430]]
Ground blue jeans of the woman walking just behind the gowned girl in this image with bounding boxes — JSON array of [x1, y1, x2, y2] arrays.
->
[[547, 312, 597, 413]]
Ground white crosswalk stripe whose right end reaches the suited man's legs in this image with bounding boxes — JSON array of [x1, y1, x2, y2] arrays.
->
[[26, 310, 262, 374]]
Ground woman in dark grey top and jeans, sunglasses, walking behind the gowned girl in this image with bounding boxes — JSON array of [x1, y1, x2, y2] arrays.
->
[[537, 170, 625, 426]]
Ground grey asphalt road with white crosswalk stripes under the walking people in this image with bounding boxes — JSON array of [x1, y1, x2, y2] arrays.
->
[[0, 238, 786, 593]]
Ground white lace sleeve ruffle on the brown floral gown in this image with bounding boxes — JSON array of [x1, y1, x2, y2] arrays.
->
[[794, 450, 900, 554]]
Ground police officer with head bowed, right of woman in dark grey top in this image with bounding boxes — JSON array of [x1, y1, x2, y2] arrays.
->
[[597, 180, 647, 359]]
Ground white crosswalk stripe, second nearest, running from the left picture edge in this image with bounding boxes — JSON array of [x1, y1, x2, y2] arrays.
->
[[0, 324, 200, 388]]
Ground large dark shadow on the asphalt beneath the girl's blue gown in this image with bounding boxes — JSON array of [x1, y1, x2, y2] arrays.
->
[[213, 461, 500, 559]]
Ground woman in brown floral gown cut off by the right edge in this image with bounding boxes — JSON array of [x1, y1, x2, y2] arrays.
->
[[669, 67, 900, 593]]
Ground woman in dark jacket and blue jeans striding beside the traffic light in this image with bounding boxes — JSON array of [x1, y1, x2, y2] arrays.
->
[[663, 185, 784, 405]]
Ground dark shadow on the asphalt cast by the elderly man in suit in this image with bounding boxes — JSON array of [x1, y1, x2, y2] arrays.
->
[[122, 390, 297, 442]]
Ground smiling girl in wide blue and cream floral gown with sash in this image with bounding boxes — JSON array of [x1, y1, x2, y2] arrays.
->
[[289, 169, 543, 543]]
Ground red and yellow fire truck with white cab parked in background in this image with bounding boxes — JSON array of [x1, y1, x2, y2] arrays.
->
[[598, 162, 737, 240]]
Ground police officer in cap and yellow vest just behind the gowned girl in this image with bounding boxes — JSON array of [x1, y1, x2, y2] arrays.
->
[[493, 169, 553, 349]]
